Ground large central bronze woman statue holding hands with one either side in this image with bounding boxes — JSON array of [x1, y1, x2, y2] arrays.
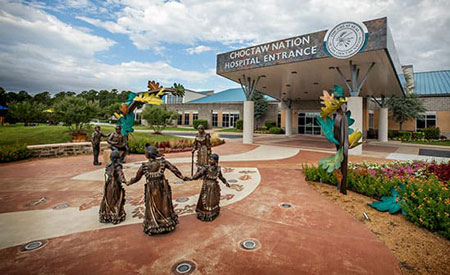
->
[[127, 144, 188, 235]]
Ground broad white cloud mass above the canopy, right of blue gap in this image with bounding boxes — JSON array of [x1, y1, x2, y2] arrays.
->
[[79, 0, 450, 70]]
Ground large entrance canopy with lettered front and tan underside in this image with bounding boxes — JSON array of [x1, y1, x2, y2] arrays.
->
[[217, 17, 404, 101]]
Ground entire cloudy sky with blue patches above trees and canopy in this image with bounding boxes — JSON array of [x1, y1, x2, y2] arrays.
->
[[0, 0, 450, 93]]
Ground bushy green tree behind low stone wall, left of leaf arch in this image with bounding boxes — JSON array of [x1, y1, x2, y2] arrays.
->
[[54, 96, 100, 133]]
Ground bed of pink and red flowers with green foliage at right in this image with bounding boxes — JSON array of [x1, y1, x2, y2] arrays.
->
[[302, 161, 450, 239]]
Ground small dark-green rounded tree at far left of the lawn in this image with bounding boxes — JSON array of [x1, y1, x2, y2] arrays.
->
[[8, 100, 45, 126]]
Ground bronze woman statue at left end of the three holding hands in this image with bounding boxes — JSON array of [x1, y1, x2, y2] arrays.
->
[[99, 151, 126, 224]]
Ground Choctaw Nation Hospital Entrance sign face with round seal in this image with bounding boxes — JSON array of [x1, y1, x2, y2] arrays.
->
[[217, 18, 386, 75]]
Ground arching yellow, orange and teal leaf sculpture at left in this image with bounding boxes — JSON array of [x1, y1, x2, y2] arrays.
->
[[114, 81, 184, 136]]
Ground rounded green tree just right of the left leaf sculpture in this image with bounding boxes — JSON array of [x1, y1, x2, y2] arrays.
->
[[142, 105, 178, 134]]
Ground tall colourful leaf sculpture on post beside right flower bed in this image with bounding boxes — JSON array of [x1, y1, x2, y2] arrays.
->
[[317, 85, 362, 194]]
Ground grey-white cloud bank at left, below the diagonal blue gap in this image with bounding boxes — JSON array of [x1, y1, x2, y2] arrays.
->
[[0, 2, 214, 92]]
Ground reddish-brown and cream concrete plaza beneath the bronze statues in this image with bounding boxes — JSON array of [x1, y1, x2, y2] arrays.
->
[[0, 137, 446, 274]]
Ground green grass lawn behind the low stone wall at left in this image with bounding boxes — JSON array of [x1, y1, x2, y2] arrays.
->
[[0, 124, 188, 146]]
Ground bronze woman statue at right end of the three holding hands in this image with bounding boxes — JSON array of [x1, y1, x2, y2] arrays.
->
[[187, 154, 230, 222]]
